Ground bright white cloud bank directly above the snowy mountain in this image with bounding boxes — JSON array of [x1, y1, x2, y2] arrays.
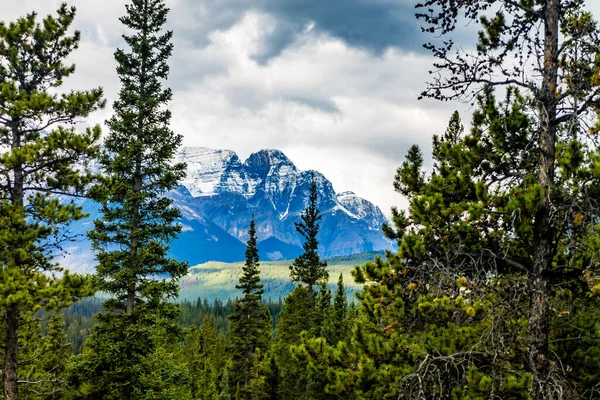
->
[[172, 13, 460, 213]]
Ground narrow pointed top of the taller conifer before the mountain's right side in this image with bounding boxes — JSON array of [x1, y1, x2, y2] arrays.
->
[[290, 172, 329, 293]]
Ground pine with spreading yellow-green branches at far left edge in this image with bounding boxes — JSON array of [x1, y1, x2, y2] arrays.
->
[[0, 5, 105, 400]]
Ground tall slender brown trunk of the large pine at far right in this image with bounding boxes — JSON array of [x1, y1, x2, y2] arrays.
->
[[527, 0, 559, 400]]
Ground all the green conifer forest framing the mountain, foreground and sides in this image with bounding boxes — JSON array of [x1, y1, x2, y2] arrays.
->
[[0, 0, 600, 400]]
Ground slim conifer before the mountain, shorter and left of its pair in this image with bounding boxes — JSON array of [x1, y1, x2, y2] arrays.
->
[[229, 217, 271, 399]]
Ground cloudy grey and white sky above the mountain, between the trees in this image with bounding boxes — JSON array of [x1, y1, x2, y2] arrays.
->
[[0, 0, 600, 214]]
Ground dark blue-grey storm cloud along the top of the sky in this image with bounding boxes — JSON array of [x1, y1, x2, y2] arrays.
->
[[176, 0, 422, 63]]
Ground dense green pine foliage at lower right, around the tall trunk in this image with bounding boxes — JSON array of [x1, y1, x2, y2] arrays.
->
[[302, 87, 600, 399]]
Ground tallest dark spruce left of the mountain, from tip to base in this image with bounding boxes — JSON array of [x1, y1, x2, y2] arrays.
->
[[74, 0, 187, 399]]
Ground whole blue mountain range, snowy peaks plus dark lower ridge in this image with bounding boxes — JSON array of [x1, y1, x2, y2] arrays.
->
[[60, 147, 392, 270]]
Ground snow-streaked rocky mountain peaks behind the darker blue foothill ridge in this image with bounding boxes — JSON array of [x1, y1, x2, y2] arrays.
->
[[172, 147, 391, 259]]
